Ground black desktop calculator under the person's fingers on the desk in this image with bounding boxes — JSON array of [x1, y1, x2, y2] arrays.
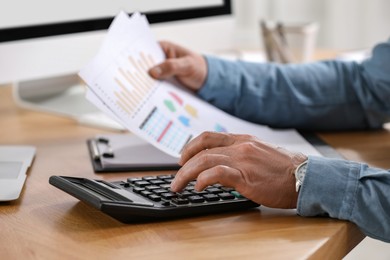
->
[[49, 175, 259, 223]]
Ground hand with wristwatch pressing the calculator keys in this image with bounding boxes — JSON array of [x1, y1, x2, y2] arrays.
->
[[171, 132, 307, 208]]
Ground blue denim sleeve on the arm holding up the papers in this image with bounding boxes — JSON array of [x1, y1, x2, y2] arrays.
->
[[198, 41, 390, 130]]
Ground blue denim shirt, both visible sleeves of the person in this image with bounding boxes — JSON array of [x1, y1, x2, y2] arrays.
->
[[198, 41, 390, 242]]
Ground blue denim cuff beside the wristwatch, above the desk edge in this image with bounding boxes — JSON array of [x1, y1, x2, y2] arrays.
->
[[297, 156, 360, 220]]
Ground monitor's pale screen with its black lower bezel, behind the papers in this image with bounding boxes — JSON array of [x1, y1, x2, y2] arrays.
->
[[0, 0, 231, 42]]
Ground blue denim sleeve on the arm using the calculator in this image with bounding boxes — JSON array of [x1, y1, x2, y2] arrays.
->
[[297, 156, 390, 242]]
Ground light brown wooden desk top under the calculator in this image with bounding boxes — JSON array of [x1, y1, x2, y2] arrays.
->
[[0, 87, 390, 259]]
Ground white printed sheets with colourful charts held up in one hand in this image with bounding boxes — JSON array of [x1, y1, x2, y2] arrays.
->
[[79, 12, 319, 157]]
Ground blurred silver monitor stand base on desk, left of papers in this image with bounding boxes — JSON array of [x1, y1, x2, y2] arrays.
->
[[13, 74, 125, 130]]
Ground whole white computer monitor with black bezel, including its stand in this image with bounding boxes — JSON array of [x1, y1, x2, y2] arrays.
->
[[0, 0, 231, 128]]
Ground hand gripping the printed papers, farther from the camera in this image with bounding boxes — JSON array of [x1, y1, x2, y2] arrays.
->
[[149, 41, 207, 91]]
